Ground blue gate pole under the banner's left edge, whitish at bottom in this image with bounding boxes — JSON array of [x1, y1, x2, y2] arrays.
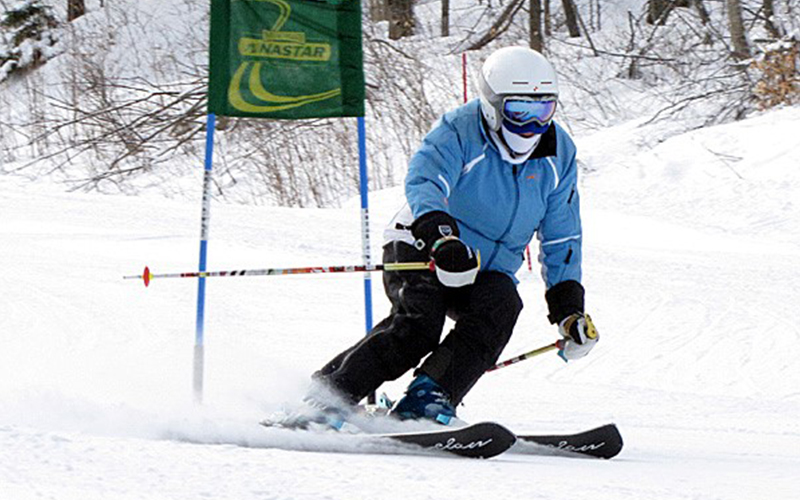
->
[[192, 113, 217, 404]]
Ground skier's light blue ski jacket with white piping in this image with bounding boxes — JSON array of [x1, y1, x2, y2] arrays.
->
[[405, 100, 581, 289]]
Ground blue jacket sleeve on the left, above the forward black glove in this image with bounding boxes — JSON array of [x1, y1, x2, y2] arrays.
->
[[405, 116, 464, 219]]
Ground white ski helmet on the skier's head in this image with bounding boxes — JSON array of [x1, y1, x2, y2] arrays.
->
[[478, 46, 558, 131]]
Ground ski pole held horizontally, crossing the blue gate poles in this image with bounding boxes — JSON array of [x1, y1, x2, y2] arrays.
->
[[122, 262, 433, 286]]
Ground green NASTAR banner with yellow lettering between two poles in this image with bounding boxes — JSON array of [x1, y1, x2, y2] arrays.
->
[[208, 0, 364, 119]]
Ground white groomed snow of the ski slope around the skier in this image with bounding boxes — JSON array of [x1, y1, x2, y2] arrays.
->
[[0, 108, 800, 500]]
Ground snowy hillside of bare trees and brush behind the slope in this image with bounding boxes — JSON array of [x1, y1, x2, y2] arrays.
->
[[0, 0, 800, 207]]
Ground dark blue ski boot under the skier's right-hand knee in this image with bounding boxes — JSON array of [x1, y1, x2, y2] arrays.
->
[[390, 375, 456, 425]]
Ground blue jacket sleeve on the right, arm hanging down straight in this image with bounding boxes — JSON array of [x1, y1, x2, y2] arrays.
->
[[537, 137, 582, 289]]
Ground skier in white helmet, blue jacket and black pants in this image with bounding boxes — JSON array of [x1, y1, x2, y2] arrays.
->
[[307, 47, 598, 426]]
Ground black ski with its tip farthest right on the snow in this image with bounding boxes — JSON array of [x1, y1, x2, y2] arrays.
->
[[511, 424, 623, 459]]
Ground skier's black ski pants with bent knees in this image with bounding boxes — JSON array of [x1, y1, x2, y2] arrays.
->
[[314, 242, 522, 405]]
